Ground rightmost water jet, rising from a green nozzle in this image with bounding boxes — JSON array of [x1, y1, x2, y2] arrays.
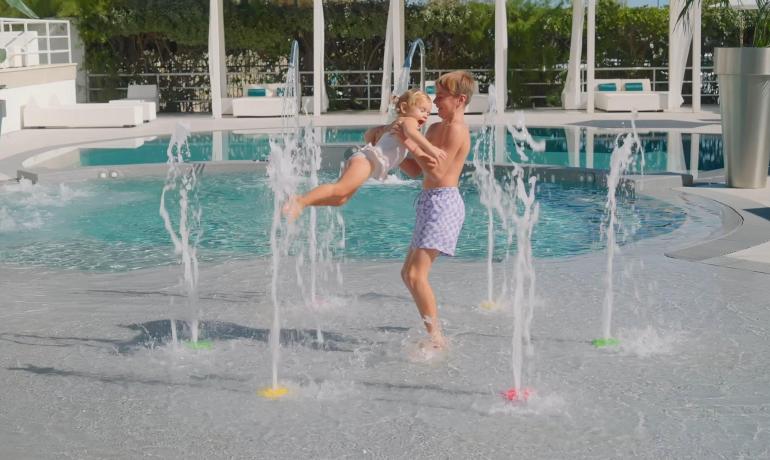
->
[[591, 118, 644, 347]]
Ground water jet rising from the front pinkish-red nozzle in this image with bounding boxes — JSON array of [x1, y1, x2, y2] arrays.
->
[[503, 166, 540, 401]]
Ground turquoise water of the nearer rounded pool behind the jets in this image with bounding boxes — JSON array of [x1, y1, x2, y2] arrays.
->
[[0, 172, 685, 271]]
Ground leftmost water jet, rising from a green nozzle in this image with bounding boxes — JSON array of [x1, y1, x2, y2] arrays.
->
[[159, 124, 211, 348]]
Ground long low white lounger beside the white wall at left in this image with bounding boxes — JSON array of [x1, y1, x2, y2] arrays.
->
[[22, 100, 144, 128]]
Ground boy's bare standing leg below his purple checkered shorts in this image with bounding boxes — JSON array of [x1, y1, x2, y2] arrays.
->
[[401, 248, 444, 346]]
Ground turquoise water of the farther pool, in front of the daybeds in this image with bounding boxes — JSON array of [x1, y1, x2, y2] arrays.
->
[[75, 127, 724, 173]]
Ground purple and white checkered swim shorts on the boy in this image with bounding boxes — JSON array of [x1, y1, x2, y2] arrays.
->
[[410, 187, 465, 256]]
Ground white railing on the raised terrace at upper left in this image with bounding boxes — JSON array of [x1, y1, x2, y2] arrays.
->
[[0, 18, 72, 68]]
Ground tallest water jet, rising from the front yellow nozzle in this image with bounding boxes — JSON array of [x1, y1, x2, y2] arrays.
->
[[259, 40, 300, 399]]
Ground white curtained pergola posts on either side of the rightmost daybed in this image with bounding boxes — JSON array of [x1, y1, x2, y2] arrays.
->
[[562, 0, 704, 113]]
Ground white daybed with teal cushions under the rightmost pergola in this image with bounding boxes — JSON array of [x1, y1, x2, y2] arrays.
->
[[594, 78, 668, 112]]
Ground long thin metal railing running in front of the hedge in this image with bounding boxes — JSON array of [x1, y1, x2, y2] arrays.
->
[[86, 66, 719, 112]]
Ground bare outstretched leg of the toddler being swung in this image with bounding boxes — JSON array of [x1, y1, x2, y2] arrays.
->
[[283, 156, 372, 220]]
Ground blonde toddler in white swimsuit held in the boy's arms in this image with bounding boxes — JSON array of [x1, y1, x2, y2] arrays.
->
[[283, 90, 446, 221]]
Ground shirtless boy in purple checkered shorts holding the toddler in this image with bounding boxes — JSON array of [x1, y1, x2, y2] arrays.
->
[[391, 71, 476, 349]]
